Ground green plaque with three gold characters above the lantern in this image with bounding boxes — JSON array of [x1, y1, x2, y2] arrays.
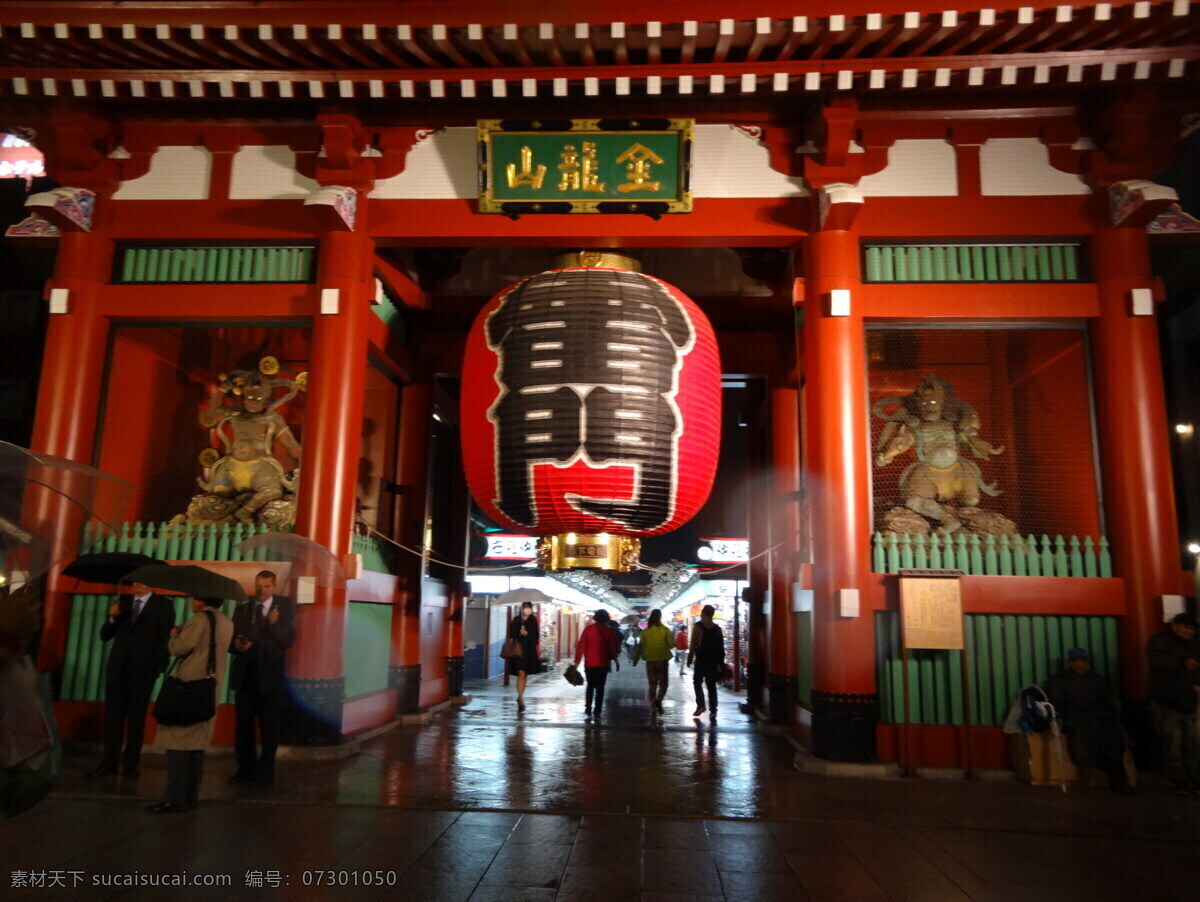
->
[[478, 119, 694, 217]]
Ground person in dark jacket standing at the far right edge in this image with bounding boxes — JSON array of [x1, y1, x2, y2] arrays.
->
[[1146, 614, 1200, 794]]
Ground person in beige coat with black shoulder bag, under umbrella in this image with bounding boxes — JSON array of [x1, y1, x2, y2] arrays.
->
[[146, 599, 233, 814]]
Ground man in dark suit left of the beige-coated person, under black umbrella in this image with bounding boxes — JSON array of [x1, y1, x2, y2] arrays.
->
[[88, 583, 175, 780]]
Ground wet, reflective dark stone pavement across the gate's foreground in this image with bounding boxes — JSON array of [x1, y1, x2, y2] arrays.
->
[[7, 665, 1200, 902]]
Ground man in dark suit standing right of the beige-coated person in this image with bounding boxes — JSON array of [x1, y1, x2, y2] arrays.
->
[[228, 570, 296, 786]]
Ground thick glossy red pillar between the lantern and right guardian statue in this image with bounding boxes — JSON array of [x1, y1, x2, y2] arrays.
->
[[804, 229, 878, 760]]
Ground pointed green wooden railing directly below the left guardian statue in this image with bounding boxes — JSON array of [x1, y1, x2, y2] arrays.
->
[[80, 521, 293, 560]]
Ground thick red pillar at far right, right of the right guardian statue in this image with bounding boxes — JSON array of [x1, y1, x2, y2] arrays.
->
[[1092, 226, 1180, 698]]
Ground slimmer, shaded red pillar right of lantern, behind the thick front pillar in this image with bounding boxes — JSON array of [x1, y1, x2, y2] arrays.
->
[[767, 389, 800, 722]]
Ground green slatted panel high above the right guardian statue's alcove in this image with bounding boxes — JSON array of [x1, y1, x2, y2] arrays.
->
[[863, 242, 1084, 282]]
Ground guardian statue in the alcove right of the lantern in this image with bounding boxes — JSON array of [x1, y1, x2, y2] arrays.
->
[[871, 374, 1016, 535]]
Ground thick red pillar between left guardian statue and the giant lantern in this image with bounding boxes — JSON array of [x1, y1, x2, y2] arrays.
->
[[284, 220, 373, 745]]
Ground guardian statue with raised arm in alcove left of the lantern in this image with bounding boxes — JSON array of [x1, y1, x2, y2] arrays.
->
[[173, 357, 307, 529]]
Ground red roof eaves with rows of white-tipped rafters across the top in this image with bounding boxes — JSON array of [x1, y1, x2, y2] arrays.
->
[[0, 0, 1200, 103]]
